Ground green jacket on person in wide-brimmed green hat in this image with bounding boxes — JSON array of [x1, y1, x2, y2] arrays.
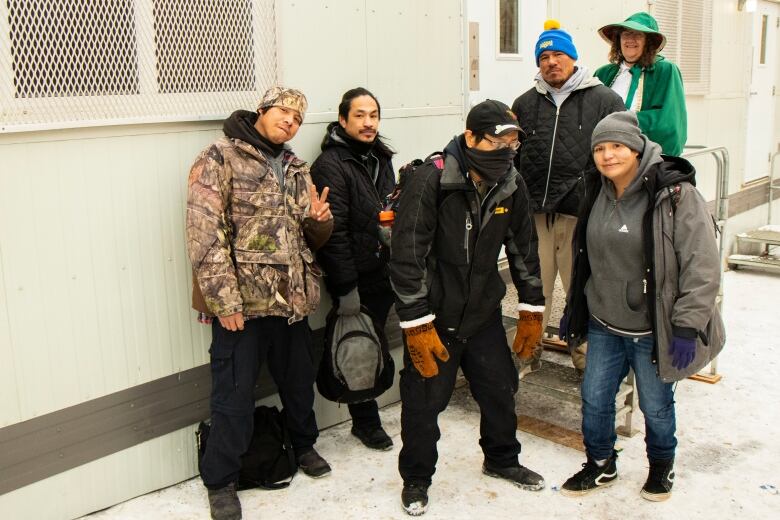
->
[[594, 55, 688, 155]]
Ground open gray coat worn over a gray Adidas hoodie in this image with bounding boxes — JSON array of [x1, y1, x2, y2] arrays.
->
[[565, 138, 725, 382]]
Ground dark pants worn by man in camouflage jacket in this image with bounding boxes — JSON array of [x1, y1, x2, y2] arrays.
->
[[201, 316, 318, 489]]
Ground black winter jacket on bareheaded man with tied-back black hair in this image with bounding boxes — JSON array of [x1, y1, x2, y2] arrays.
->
[[311, 122, 395, 297]]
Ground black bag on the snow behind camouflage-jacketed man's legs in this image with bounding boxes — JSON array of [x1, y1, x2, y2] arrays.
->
[[195, 406, 298, 490]]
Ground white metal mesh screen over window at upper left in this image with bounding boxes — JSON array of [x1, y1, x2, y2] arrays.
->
[[0, 0, 277, 132]]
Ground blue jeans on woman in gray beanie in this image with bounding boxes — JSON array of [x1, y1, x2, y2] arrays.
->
[[582, 320, 677, 460]]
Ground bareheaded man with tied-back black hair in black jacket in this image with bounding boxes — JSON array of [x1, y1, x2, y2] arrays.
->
[[311, 87, 395, 450]]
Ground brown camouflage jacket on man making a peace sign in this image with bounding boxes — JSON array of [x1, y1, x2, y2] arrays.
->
[[187, 137, 321, 323]]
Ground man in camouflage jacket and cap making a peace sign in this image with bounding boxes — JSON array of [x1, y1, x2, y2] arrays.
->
[[187, 87, 333, 518]]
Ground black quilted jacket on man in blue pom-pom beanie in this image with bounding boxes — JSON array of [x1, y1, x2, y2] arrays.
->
[[512, 76, 626, 216]]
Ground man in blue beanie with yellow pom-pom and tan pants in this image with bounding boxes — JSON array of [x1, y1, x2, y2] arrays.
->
[[512, 20, 625, 374]]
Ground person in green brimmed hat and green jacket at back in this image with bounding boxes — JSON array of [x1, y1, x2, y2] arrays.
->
[[594, 12, 688, 155]]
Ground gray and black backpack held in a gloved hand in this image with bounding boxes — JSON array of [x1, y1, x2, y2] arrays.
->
[[317, 307, 395, 404]]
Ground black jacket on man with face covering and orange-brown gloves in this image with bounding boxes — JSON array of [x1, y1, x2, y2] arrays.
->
[[390, 136, 544, 338]]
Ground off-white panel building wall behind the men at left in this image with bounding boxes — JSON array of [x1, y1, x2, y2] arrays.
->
[[0, 0, 466, 519]]
